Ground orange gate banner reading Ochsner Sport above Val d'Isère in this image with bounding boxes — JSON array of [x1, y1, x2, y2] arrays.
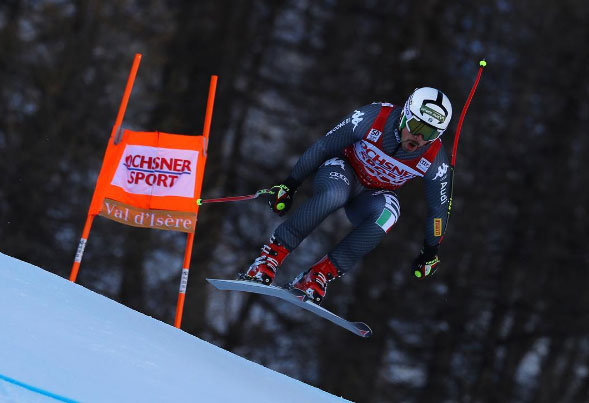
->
[[90, 130, 205, 232]]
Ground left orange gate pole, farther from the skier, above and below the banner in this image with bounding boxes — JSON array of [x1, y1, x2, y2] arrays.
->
[[70, 53, 141, 283]]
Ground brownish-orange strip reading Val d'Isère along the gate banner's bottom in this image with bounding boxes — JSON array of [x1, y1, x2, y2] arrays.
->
[[100, 199, 196, 232]]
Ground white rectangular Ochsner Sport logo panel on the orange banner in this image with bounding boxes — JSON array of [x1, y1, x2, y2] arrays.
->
[[111, 144, 198, 197]]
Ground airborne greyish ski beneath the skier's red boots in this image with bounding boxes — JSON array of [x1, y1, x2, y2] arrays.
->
[[207, 278, 372, 337]]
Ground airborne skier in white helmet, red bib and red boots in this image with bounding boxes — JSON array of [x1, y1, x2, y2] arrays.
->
[[239, 87, 452, 304]]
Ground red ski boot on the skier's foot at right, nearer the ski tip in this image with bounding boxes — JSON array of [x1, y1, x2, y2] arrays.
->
[[288, 255, 343, 305]]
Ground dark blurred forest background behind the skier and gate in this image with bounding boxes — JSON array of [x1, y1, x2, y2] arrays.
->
[[0, 0, 589, 402]]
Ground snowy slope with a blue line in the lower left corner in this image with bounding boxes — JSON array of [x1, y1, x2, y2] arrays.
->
[[0, 253, 344, 403]]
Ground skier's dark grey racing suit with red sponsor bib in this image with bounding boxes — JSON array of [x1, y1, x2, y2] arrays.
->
[[274, 103, 451, 273]]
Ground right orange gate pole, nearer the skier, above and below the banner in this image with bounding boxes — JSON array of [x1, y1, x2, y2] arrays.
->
[[174, 76, 218, 329]]
